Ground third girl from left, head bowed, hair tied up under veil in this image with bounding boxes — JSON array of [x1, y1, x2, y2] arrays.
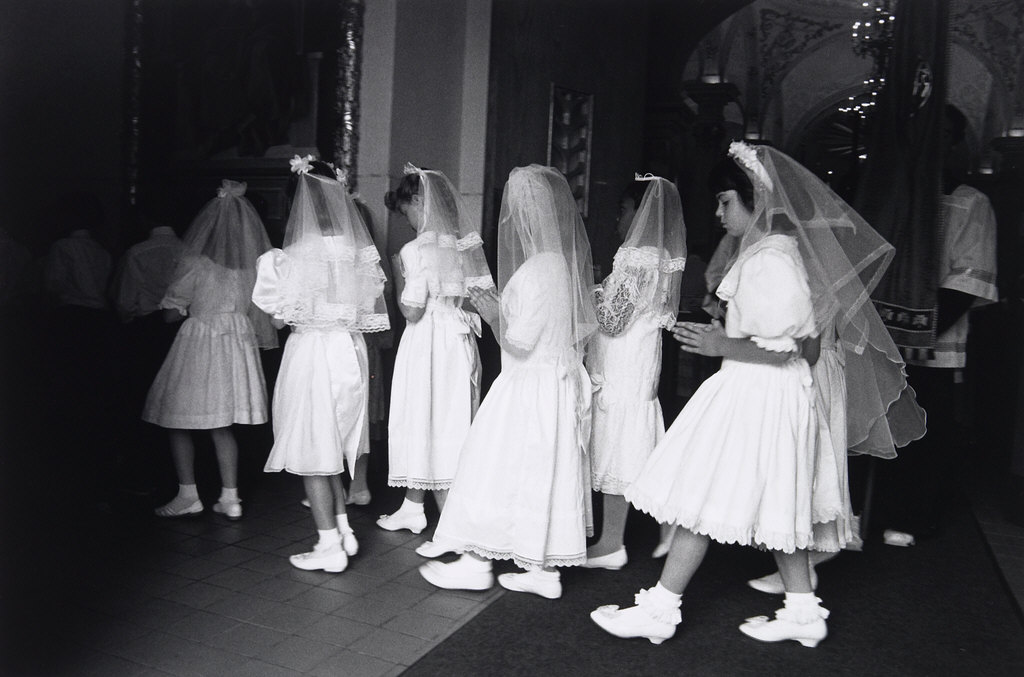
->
[[377, 165, 495, 544]]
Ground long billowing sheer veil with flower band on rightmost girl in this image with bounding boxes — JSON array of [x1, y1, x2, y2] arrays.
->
[[729, 142, 925, 458]]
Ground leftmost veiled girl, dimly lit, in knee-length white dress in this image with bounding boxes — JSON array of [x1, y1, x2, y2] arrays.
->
[[142, 180, 278, 519]]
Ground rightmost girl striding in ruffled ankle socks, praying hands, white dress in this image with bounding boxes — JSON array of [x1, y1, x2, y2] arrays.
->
[[591, 142, 868, 646]]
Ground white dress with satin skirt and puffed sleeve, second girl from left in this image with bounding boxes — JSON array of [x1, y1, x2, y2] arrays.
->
[[253, 249, 370, 475]]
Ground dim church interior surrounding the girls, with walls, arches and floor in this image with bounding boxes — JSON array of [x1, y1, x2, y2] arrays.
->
[[0, 0, 1024, 676]]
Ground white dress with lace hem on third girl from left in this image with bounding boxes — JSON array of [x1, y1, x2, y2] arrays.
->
[[387, 239, 480, 490]]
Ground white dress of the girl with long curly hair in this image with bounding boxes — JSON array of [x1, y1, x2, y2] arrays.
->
[[587, 267, 674, 496]]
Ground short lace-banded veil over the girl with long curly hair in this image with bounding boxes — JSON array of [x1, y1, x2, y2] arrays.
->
[[612, 174, 686, 327]]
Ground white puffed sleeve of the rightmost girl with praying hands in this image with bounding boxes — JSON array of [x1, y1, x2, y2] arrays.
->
[[726, 248, 816, 352]]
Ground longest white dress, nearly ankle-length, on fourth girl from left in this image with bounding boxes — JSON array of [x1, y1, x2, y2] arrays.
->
[[434, 253, 590, 568]]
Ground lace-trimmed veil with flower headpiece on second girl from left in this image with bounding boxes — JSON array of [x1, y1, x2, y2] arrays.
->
[[279, 158, 390, 332]]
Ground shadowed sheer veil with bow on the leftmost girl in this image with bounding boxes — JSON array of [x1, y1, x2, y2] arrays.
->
[[175, 179, 278, 348]]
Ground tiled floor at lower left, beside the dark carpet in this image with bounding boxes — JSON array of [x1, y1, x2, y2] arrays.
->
[[50, 476, 501, 677]]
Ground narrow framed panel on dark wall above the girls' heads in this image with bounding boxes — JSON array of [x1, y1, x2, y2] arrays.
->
[[548, 83, 594, 218]]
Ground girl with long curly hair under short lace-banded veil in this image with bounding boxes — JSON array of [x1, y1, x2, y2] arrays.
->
[[584, 174, 686, 569]]
